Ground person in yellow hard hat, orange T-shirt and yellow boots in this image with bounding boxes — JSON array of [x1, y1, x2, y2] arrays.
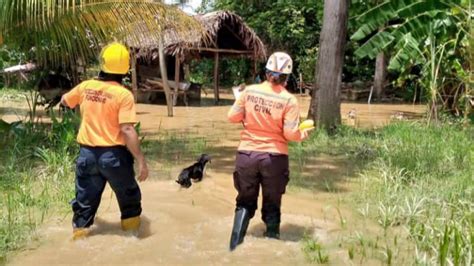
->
[[61, 43, 148, 239]]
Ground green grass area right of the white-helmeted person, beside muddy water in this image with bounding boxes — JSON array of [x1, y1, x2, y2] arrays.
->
[[291, 122, 474, 265]]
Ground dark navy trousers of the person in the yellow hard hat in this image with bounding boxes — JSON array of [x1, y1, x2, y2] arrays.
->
[[71, 146, 142, 228]]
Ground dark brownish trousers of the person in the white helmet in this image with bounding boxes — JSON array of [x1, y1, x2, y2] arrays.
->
[[234, 151, 289, 224]]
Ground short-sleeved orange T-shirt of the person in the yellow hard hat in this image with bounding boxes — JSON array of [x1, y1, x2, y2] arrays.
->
[[63, 80, 137, 147]]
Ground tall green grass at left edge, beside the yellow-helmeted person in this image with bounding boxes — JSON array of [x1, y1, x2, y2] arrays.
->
[[0, 109, 79, 262]]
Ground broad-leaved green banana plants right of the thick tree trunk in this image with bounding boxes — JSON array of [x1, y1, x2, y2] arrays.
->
[[351, 0, 472, 119]]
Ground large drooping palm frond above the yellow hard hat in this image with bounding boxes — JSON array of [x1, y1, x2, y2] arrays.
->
[[0, 0, 205, 66]]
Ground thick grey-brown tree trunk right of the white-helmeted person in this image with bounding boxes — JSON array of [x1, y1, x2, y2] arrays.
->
[[310, 0, 349, 131]]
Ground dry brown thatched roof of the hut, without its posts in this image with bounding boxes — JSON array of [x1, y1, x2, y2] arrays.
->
[[129, 11, 266, 60]]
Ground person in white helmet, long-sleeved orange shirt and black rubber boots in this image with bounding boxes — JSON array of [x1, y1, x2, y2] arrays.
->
[[228, 52, 313, 251]]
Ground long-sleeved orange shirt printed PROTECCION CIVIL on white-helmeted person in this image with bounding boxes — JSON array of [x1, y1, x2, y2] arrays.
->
[[227, 82, 308, 154]]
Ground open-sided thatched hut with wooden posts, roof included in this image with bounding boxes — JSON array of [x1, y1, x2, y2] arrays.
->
[[128, 11, 266, 107]]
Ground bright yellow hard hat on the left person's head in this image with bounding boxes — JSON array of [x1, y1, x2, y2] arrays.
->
[[100, 42, 130, 74]]
